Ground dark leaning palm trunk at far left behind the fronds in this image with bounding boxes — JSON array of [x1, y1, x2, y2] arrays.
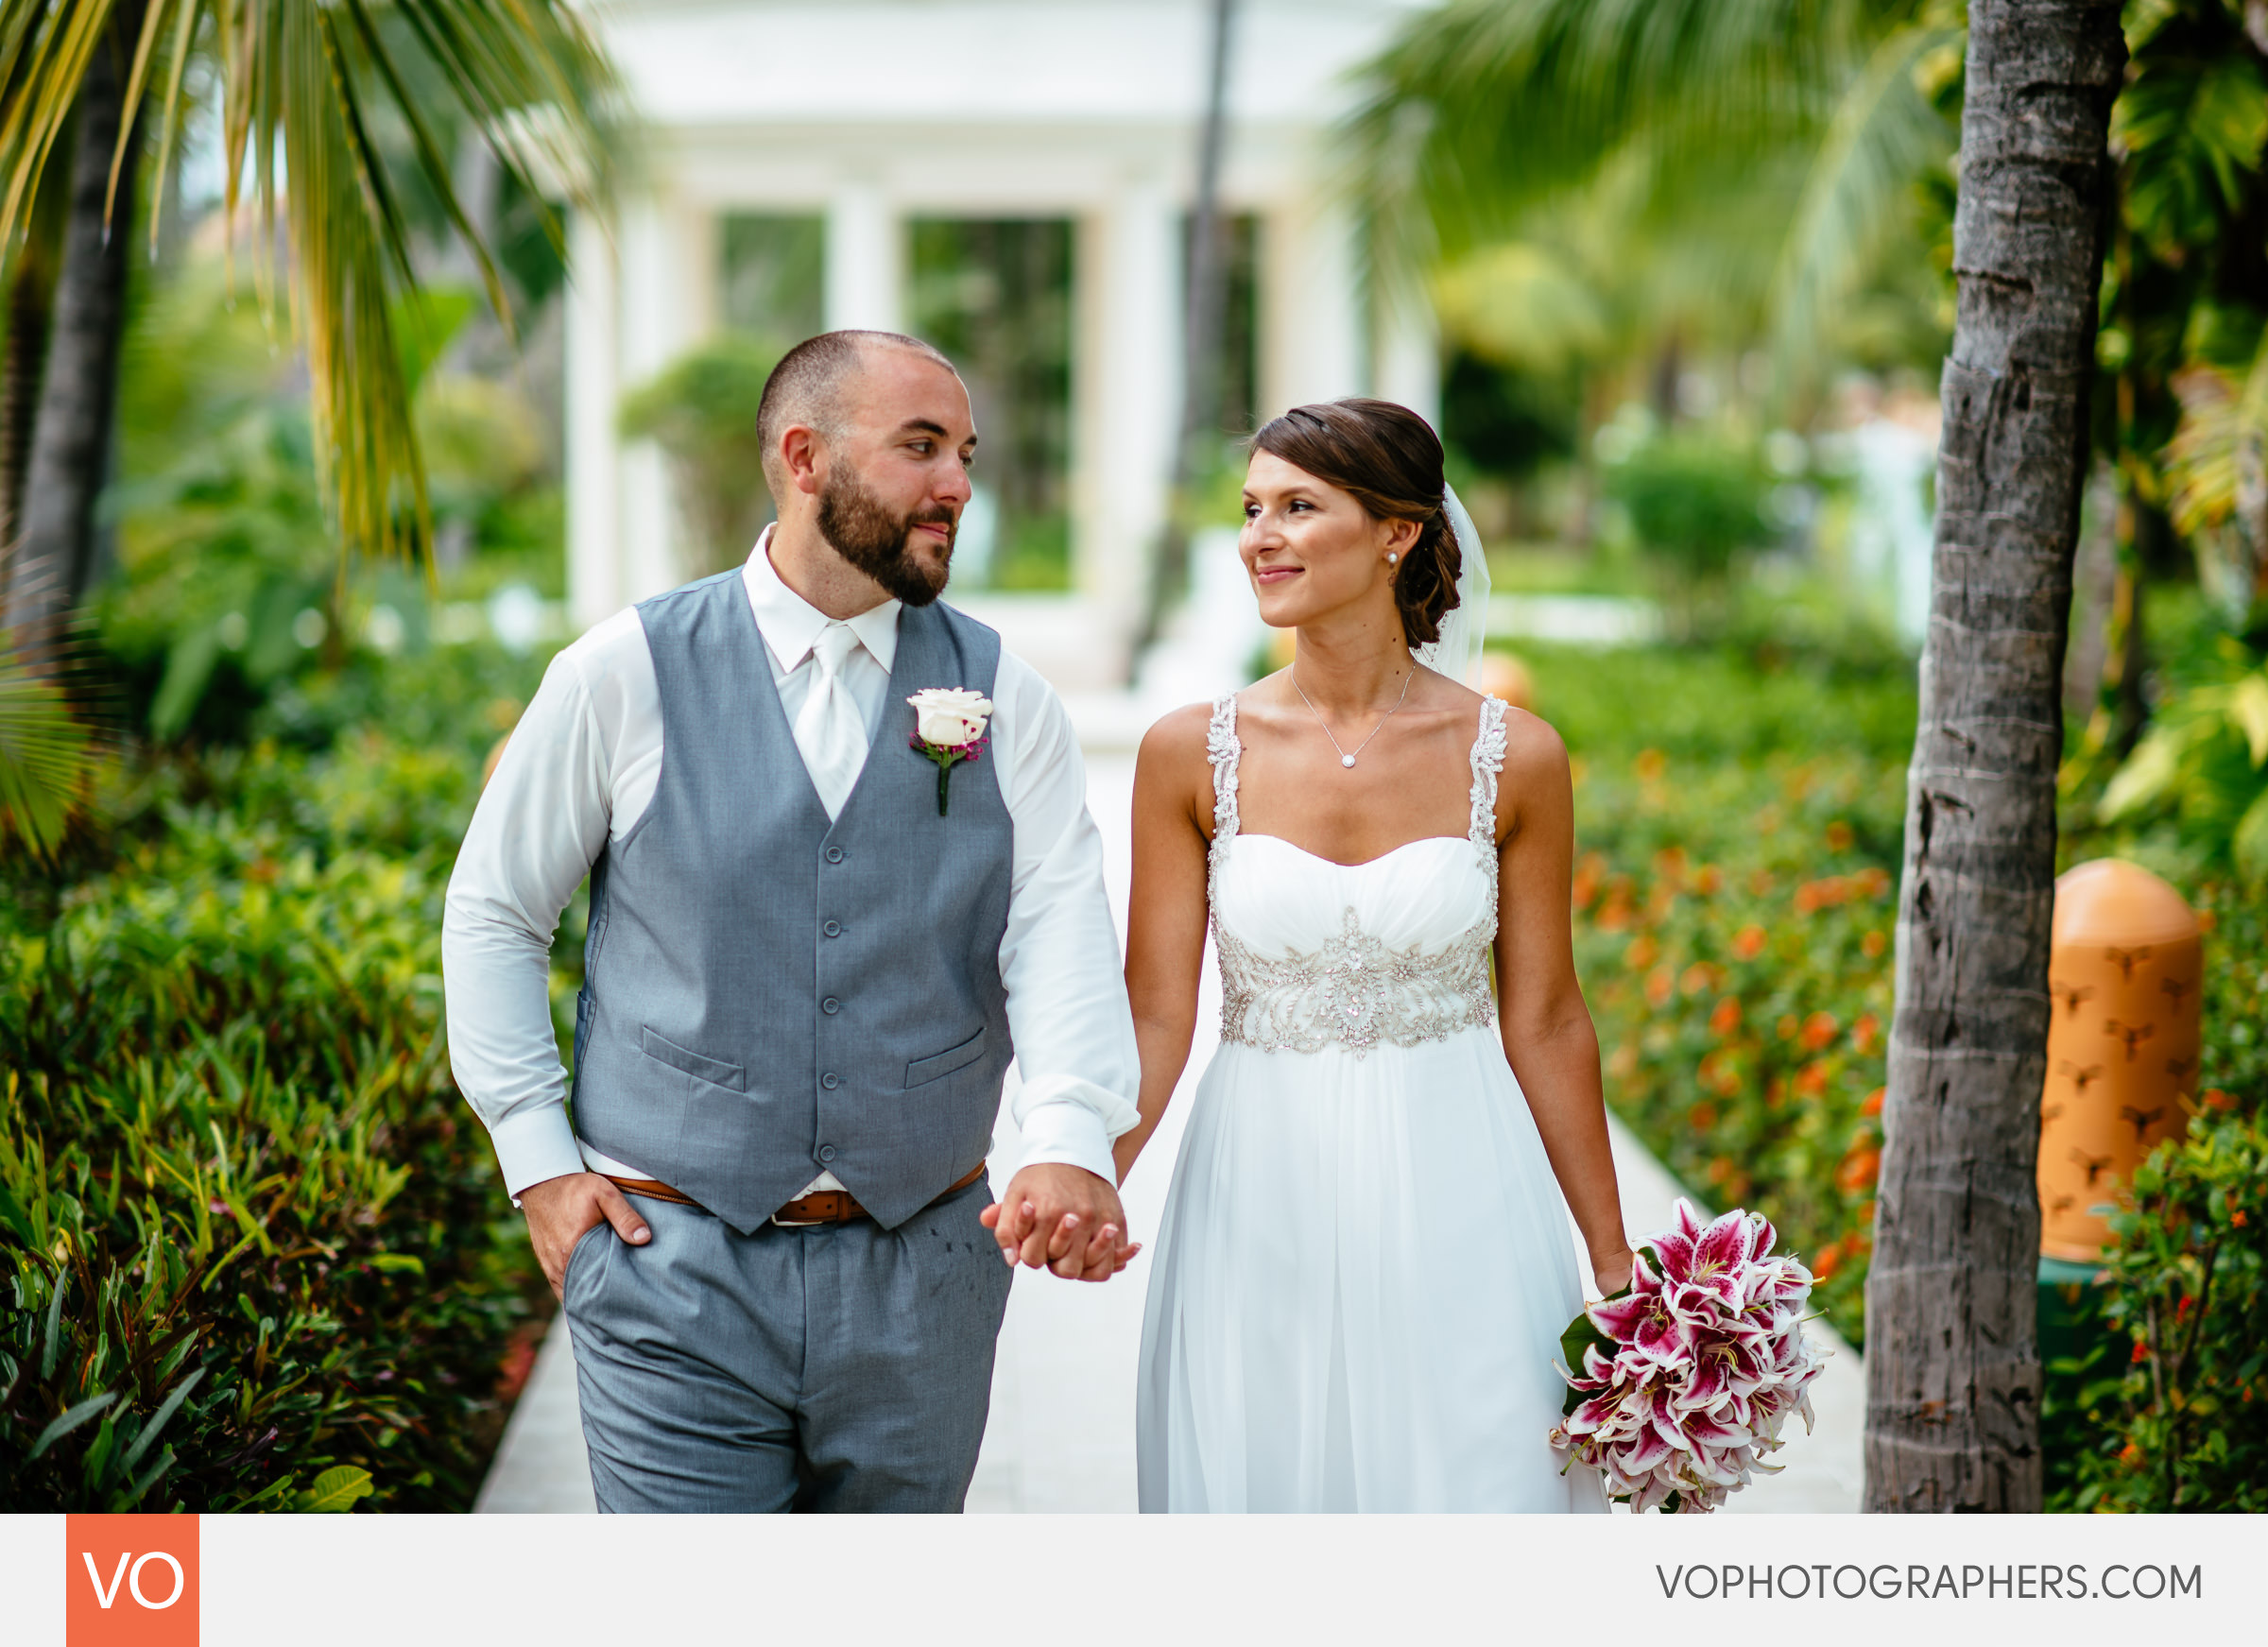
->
[[9, 0, 146, 633]]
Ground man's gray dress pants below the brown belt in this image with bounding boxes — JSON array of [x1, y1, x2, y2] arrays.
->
[[562, 1179, 1011, 1513]]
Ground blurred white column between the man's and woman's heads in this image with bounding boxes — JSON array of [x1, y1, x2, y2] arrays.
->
[[1071, 177, 1181, 674]]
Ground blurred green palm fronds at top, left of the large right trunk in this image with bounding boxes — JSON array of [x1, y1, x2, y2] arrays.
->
[[1351, 0, 1960, 420]]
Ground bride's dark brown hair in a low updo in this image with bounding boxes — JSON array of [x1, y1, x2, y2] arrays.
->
[[1252, 400, 1463, 646]]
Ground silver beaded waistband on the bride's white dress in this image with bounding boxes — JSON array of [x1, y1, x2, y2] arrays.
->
[[1213, 910, 1497, 1057]]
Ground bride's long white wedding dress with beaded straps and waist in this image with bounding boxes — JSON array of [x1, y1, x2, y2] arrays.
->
[[1136, 696, 1606, 1511]]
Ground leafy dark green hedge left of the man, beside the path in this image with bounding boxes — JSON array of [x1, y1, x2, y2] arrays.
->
[[0, 737, 542, 1511]]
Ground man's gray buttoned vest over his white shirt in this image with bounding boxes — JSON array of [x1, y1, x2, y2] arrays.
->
[[574, 572, 1014, 1232]]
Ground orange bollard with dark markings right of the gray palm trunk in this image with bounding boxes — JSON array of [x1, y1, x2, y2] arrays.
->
[[2039, 858, 2202, 1263]]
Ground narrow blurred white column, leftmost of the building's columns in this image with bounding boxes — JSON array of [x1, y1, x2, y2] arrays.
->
[[567, 211, 626, 628]]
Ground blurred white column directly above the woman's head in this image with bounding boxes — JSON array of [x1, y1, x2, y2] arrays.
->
[[1259, 195, 1366, 420]]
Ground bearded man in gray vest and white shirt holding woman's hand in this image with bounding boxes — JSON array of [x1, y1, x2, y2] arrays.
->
[[442, 332, 1136, 1511]]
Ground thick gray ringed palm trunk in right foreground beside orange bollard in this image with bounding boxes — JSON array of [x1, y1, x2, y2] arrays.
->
[[1866, 0, 2125, 1511]]
